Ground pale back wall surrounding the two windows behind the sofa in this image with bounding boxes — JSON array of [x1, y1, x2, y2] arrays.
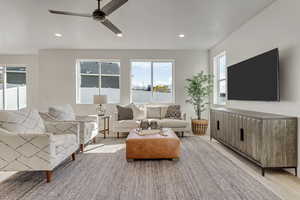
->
[[39, 49, 208, 115]]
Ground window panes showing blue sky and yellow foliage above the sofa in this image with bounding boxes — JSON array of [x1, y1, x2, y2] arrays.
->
[[131, 61, 174, 103]]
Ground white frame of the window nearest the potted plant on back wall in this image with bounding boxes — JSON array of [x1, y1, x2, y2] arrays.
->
[[129, 59, 175, 104]]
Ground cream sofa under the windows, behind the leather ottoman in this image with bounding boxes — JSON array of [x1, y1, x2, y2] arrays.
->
[[112, 105, 189, 137]]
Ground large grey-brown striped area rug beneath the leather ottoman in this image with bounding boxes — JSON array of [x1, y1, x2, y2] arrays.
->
[[0, 137, 280, 200]]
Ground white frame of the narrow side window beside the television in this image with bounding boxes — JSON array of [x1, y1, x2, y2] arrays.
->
[[213, 51, 228, 105]]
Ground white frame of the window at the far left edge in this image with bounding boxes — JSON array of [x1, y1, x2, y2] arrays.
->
[[0, 64, 28, 110]]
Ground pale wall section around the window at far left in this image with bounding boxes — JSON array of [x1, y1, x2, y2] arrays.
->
[[0, 55, 38, 107]]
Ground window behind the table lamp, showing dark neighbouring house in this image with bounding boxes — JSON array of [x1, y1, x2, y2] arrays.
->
[[76, 60, 120, 104]]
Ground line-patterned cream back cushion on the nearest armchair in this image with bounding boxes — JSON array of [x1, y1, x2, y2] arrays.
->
[[0, 109, 46, 134]]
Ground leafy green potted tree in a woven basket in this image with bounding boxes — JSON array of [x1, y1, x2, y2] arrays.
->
[[185, 71, 213, 135]]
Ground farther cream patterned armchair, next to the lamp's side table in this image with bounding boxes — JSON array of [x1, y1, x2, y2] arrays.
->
[[40, 105, 99, 152]]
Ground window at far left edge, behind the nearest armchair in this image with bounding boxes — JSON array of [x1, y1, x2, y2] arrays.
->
[[0, 65, 27, 110]]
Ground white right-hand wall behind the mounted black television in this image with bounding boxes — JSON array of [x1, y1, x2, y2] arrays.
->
[[210, 0, 300, 175]]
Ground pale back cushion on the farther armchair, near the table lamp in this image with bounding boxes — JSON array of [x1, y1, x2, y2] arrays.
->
[[49, 104, 75, 121]]
